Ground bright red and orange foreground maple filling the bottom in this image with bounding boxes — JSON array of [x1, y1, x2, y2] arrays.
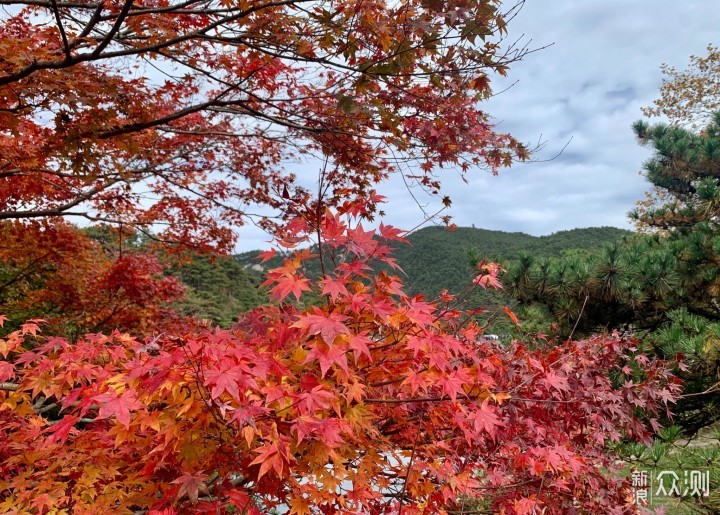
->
[[0, 211, 680, 514]]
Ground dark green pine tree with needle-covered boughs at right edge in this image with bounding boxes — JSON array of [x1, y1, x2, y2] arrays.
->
[[504, 113, 720, 432]]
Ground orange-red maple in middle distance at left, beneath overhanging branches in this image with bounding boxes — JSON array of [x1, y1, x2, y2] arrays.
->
[[0, 221, 188, 339]]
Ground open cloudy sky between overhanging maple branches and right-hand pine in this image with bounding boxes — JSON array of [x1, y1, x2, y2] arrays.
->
[[233, 0, 720, 251]]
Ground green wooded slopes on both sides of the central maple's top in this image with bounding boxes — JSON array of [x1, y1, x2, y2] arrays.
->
[[172, 227, 632, 326]]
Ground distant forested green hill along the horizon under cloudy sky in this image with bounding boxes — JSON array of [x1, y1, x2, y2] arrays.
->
[[237, 227, 632, 296]]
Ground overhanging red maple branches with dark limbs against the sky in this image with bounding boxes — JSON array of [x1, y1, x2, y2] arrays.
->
[[0, 0, 527, 250]]
